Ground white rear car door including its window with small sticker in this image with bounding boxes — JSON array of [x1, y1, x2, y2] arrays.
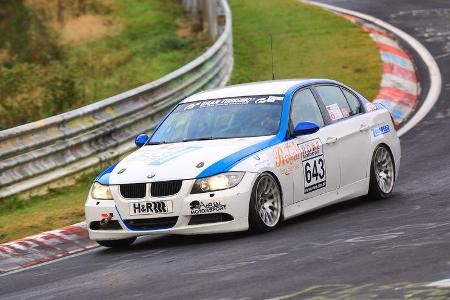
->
[[314, 85, 370, 187]]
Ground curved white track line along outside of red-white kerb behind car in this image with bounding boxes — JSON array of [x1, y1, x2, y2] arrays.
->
[[298, 0, 442, 136]]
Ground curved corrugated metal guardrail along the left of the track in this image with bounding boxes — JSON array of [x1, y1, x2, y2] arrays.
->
[[0, 0, 233, 198]]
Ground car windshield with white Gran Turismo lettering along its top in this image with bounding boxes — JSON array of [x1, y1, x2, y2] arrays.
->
[[148, 95, 283, 144]]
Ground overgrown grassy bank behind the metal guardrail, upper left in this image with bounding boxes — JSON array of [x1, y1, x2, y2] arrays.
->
[[0, 0, 210, 130]]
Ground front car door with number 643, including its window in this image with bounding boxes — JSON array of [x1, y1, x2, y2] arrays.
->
[[290, 88, 340, 202]]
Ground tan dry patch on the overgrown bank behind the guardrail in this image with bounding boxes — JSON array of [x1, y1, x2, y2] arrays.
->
[[59, 15, 118, 45]]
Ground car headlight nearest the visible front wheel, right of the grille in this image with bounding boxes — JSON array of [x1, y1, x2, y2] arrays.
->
[[191, 172, 244, 194]]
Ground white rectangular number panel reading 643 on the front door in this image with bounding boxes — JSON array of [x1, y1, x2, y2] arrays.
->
[[298, 139, 327, 194]]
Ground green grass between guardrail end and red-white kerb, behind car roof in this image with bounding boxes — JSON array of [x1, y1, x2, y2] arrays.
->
[[229, 0, 382, 99]]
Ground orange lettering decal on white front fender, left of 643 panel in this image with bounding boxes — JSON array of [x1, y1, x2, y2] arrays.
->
[[273, 141, 300, 175]]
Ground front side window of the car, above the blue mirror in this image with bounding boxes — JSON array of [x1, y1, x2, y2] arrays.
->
[[291, 89, 324, 127]]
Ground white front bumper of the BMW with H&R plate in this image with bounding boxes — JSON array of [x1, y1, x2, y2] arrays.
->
[[85, 173, 257, 240]]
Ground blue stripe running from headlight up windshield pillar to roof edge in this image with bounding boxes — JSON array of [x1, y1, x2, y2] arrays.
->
[[196, 80, 337, 178]]
